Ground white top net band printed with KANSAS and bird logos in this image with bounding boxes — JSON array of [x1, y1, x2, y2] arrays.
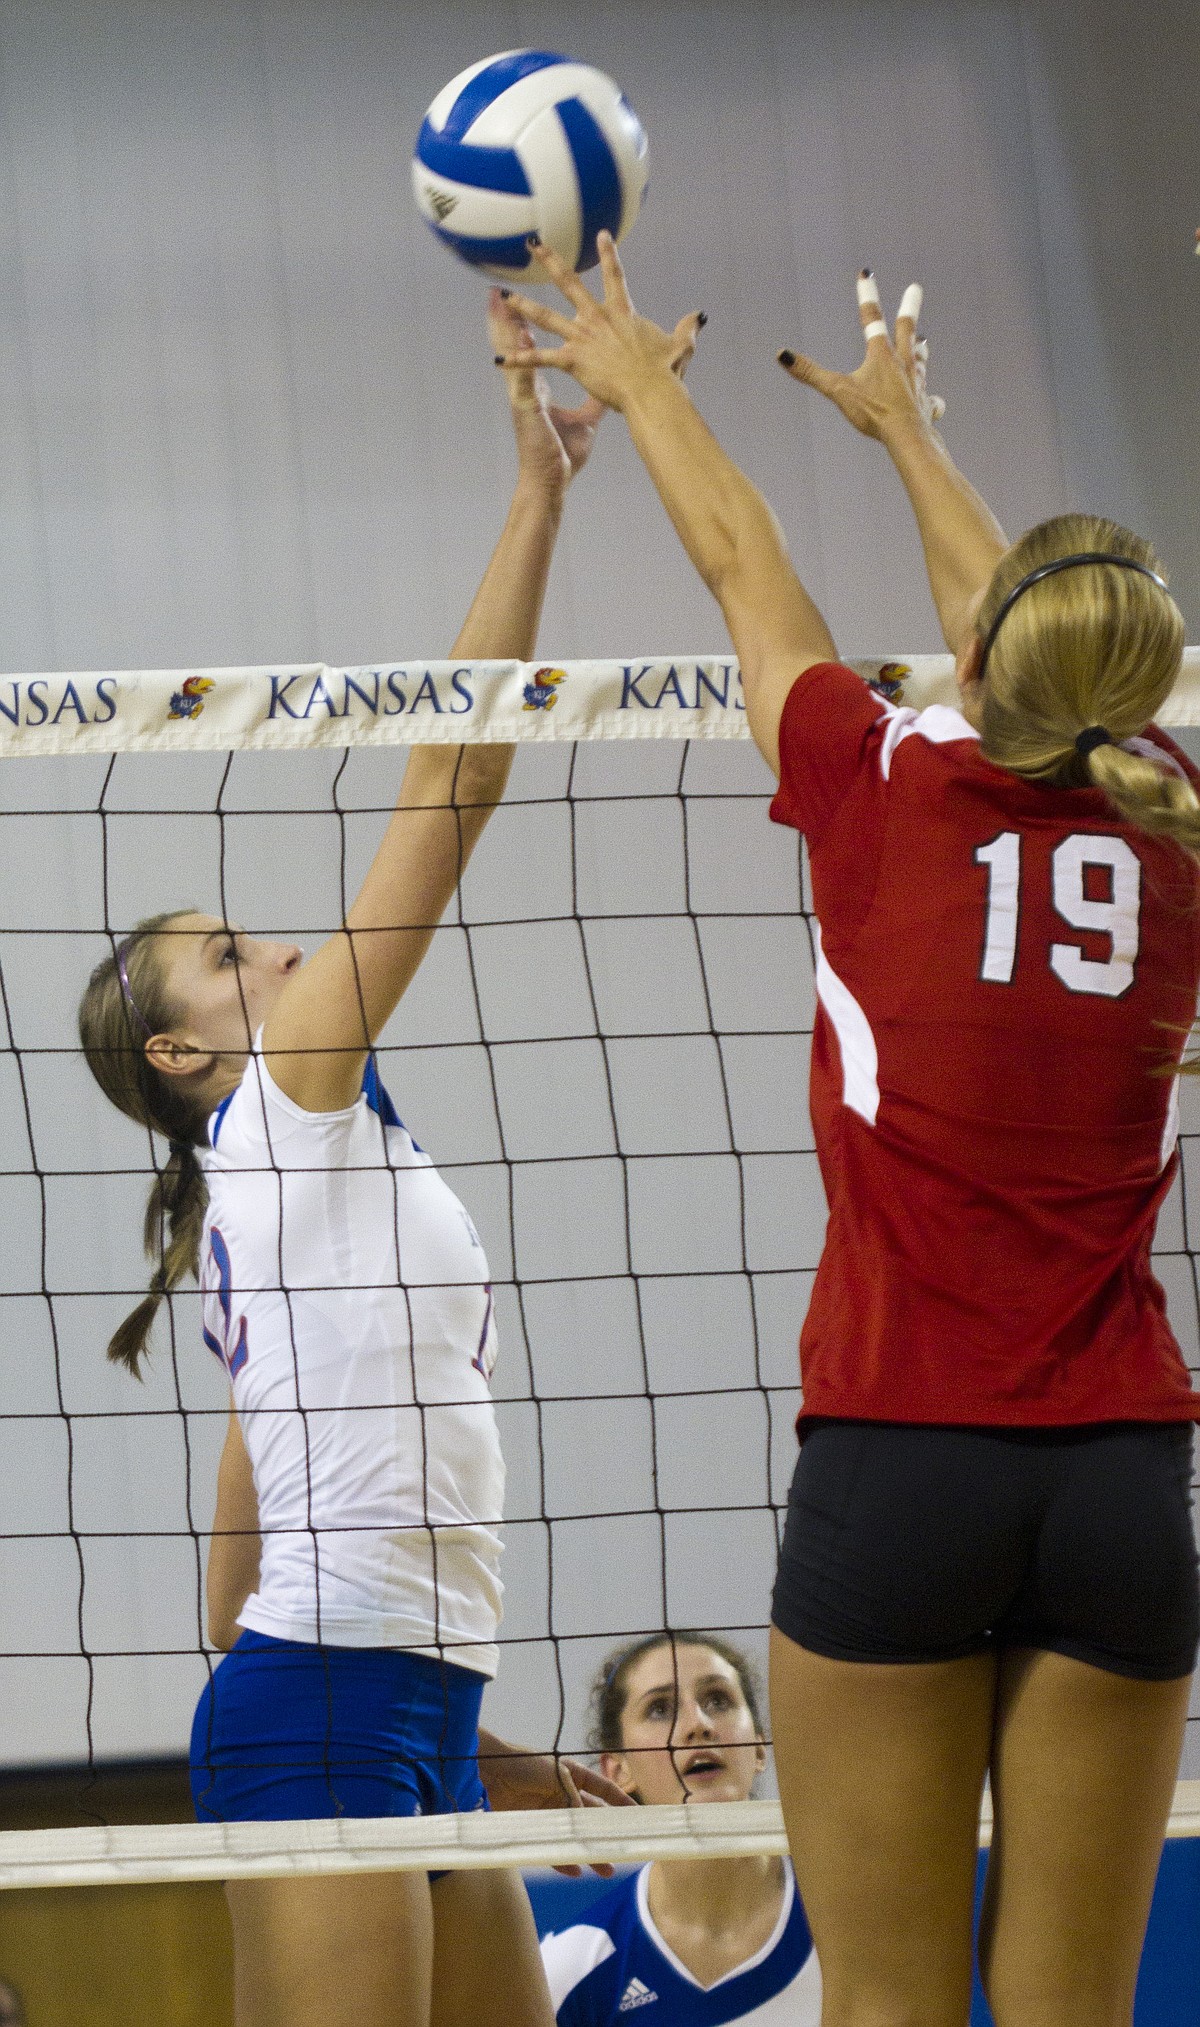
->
[[0, 649, 1200, 758]]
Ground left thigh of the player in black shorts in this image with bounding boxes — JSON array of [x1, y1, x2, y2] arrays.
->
[[770, 1628, 995, 2027]]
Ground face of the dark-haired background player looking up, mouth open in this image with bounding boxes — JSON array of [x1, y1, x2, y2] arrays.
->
[[602, 1646, 766, 1802]]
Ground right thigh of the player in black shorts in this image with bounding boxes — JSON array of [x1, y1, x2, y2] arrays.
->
[[979, 1652, 1190, 2027]]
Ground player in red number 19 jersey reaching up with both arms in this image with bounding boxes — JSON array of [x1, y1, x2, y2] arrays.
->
[[506, 243, 1200, 2027]]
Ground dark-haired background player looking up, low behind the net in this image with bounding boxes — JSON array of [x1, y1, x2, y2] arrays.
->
[[541, 1634, 821, 2027]]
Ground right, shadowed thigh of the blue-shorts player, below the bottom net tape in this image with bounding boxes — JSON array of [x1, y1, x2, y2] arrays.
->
[[430, 1871, 553, 2027]]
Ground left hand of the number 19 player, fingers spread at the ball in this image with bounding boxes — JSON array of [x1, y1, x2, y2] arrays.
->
[[496, 233, 705, 409]]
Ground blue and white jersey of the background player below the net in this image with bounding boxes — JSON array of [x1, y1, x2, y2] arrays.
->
[[541, 1859, 821, 2027]]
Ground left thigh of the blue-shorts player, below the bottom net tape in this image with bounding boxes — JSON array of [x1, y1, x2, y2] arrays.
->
[[225, 1873, 434, 2027]]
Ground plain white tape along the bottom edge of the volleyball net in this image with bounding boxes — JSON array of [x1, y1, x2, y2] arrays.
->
[[0, 1780, 1200, 1887]]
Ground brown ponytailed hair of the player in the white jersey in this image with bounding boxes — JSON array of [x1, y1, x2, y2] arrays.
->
[[79, 910, 209, 1378]]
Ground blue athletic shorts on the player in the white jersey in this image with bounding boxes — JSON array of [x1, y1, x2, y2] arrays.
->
[[191, 1632, 486, 1822]]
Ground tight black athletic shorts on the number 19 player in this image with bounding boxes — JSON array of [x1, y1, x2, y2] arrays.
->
[[772, 1421, 1200, 1682]]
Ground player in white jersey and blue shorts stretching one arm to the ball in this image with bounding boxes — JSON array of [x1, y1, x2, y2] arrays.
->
[[79, 292, 622, 2027]]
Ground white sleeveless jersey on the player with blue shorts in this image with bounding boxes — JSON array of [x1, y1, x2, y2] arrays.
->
[[199, 1040, 505, 1674]]
